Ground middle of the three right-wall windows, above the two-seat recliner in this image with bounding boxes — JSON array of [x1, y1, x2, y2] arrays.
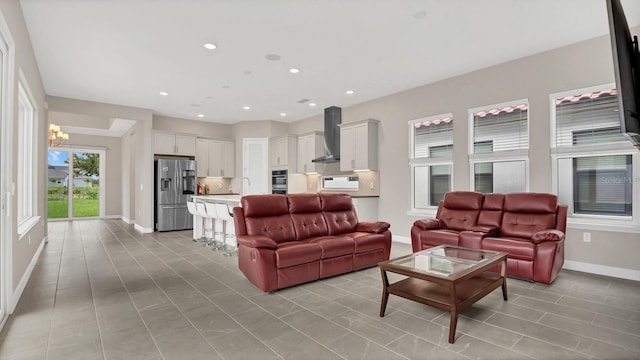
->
[[469, 100, 529, 193]]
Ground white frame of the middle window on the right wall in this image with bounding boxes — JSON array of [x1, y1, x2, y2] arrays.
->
[[467, 98, 531, 191]]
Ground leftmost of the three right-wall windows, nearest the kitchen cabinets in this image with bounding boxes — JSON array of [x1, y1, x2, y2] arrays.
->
[[409, 114, 453, 211]]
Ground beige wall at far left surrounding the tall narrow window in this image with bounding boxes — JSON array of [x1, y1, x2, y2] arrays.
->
[[0, 1, 47, 300]]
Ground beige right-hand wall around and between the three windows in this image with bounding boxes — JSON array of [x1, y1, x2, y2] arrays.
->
[[290, 30, 640, 270]]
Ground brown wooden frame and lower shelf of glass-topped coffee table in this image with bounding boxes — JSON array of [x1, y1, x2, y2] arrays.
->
[[378, 245, 508, 344]]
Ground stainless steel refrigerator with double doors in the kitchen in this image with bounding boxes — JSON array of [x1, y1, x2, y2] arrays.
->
[[154, 159, 197, 231]]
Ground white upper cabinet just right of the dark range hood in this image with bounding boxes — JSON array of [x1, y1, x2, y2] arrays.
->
[[340, 119, 380, 171]]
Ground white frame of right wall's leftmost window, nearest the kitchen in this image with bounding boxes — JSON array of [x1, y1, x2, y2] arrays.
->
[[407, 113, 455, 216]]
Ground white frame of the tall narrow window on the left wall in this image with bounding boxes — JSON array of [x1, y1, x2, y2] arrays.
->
[[16, 69, 40, 239]]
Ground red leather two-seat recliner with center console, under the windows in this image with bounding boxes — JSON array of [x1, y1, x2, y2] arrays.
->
[[411, 191, 567, 284]]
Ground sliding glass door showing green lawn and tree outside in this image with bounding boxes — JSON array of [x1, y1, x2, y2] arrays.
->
[[47, 148, 105, 219]]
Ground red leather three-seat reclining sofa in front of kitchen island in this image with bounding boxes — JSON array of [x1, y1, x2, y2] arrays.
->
[[233, 194, 391, 291]]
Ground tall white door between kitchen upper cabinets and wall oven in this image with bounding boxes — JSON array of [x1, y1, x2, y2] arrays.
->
[[240, 138, 270, 195]]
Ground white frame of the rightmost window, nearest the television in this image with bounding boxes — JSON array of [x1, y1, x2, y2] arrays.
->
[[549, 83, 640, 233]]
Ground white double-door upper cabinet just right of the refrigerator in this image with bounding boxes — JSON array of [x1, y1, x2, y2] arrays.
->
[[196, 139, 236, 178]]
